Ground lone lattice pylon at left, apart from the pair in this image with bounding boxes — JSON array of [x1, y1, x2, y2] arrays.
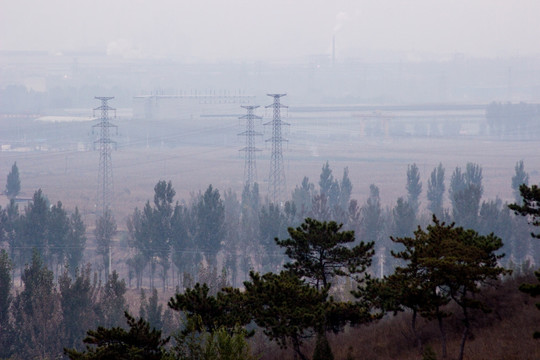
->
[[92, 96, 118, 216]]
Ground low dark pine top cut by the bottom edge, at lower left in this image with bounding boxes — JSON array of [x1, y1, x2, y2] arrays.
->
[[64, 311, 169, 360]]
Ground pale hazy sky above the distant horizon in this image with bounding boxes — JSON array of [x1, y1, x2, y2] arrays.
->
[[0, 0, 540, 61]]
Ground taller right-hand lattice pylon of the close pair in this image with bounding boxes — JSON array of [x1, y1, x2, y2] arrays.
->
[[264, 94, 289, 204]]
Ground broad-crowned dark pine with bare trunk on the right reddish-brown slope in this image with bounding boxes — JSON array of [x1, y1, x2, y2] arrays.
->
[[391, 217, 508, 359]]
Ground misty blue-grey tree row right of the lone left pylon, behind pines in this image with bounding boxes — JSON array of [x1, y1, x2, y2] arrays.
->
[[120, 161, 539, 287]]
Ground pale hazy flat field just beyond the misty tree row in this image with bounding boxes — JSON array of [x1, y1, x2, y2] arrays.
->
[[0, 134, 540, 229]]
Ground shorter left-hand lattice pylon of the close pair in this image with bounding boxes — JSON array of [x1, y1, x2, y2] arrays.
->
[[238, 105, 262, 187]]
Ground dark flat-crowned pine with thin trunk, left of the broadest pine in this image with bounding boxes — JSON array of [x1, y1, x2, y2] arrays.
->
[[274, 218, 374, 354]]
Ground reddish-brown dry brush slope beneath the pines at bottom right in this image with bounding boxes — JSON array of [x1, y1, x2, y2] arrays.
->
[[252, 274, 540, 360]]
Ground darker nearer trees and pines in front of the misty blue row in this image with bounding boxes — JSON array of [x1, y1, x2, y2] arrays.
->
[[0, 217, 532, 360]]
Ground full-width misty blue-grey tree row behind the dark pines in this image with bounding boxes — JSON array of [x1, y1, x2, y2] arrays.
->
[[0, 161, 540, 288]]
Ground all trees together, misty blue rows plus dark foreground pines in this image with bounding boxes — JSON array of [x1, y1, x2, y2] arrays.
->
[[0, 162, 537, 359]]
